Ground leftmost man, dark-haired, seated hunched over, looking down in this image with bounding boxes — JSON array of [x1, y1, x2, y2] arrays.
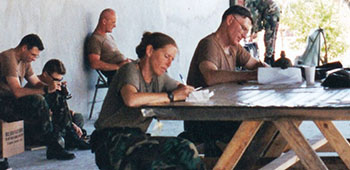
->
[[0, 34, 75, 160]]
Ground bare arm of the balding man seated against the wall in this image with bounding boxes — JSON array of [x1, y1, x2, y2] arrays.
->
[[88, 54, 128, 71]]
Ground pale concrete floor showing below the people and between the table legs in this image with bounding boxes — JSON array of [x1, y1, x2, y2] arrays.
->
[[4, 118, 350, 170]]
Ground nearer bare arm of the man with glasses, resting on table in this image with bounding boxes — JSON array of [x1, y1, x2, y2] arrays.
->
[[199, 61, 257, 86]]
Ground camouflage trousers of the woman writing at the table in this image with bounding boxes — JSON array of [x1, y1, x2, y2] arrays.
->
[[90, 128, 204, 170]]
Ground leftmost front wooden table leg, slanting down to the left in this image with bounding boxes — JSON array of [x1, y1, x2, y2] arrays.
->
[[214, 121, 263, 170]]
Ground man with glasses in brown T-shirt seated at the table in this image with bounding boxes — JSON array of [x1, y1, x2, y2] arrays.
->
[[180, 6, 268, 156]]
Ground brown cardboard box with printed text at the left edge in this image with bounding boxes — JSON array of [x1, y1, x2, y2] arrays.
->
[[0, 120, 24, 158]]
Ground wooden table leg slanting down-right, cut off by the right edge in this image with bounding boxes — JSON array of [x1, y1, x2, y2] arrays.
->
[[314, 120, 350, 169]]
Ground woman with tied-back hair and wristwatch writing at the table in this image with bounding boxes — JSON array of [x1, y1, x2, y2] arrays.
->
[[91, 32, 202, 170]]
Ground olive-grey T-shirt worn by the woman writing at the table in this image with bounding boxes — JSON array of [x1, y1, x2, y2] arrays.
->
[[95, 61, 178, 132]]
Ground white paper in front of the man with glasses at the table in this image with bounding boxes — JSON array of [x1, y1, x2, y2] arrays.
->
[[258, 67, 303, 84]]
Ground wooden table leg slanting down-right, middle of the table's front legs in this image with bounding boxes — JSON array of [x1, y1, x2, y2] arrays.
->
[[274, 120, 328, 170]]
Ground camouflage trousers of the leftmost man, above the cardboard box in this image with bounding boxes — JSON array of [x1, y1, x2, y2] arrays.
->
[[0, 95, 53, 143]]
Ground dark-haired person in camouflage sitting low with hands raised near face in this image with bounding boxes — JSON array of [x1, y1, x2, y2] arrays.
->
[[25, 59, 90, 150]]
